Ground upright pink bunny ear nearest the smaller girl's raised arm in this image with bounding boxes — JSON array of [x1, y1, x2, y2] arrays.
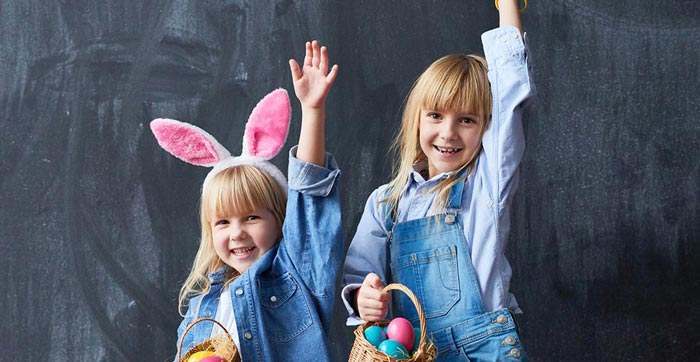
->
[[243, 88, 292, 160]]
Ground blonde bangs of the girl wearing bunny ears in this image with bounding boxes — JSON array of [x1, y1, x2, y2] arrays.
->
[[202, 165, 286, 225]]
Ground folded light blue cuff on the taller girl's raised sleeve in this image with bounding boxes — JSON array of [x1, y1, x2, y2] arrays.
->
[[481, 26, 527, 67]]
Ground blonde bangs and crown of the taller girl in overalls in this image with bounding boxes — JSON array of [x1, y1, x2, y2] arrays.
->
[[417, 55, 491, 117]]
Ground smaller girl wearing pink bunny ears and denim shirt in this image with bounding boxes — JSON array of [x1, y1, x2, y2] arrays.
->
[[151, 41, 343, 361]]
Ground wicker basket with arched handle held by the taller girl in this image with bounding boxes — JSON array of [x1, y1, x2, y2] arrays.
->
[[348, 283, 437, 362]]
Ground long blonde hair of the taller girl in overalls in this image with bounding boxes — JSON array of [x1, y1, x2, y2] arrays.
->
[[380, 54, 492, 213]]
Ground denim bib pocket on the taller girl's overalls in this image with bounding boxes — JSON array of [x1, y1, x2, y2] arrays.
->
[[393, 245, 460, 321]]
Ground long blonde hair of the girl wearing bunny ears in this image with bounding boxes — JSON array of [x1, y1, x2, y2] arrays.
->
[[178, 165, 287, 315]]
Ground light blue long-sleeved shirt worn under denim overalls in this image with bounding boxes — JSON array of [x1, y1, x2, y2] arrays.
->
[[342, 27, 532, 325]]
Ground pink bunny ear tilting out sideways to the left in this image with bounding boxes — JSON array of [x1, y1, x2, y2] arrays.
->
[[151, 118, 231, 167]]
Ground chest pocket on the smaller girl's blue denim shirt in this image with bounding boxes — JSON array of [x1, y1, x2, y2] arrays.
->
[[259, 273, 313, 342]]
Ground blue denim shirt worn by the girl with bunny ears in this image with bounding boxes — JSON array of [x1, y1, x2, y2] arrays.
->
[[178, 147, 343, 361]]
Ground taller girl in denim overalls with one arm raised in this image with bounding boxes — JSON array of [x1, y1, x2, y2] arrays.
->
[[343, 0, 531, 361]]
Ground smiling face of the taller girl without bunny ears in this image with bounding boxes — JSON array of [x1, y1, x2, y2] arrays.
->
[[419, 109, 482, 178]]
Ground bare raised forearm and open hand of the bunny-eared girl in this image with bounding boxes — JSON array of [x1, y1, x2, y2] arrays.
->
[[289, 40, 338, 166]]
